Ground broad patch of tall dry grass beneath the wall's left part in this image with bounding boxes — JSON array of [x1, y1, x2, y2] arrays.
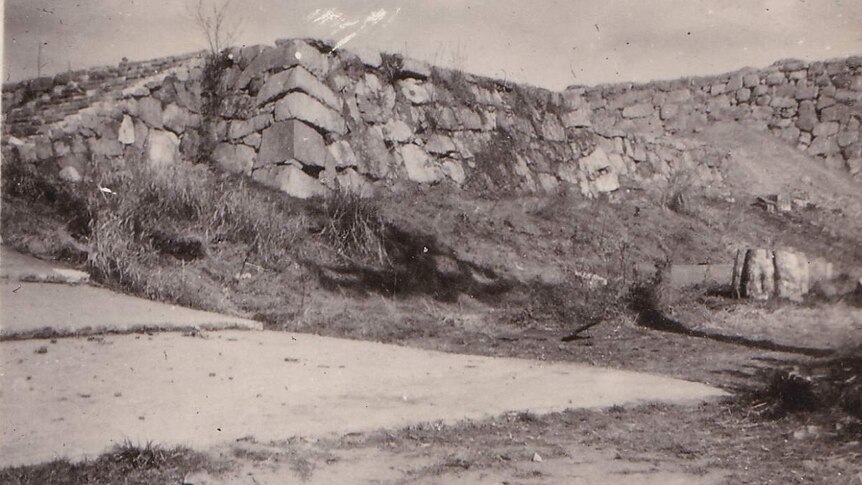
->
[[89, 162, 306, 296]]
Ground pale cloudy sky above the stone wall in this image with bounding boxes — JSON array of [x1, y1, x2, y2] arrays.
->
[[2, 0, 862, 89]]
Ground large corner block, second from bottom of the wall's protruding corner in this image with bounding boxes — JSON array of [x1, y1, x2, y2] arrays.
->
[[257, 120, 329, 167]]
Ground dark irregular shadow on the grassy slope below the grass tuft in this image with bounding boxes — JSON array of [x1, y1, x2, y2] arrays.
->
[[306, 226, 515, 302]]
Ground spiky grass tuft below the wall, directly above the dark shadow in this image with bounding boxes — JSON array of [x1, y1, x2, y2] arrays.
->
[[323, 190, 390, 265]]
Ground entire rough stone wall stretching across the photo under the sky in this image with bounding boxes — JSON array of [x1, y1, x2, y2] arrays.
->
[[2, 39, 862, 198]]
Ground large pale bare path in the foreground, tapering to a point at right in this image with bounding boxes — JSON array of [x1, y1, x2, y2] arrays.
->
[[0, 331, 723, 466]]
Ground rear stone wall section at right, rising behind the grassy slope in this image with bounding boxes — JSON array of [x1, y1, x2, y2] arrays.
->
[[563, 56, 862, 177]]
